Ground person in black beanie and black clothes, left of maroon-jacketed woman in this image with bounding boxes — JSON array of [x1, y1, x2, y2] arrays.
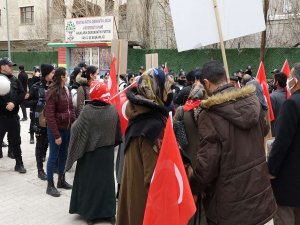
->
[[28, 64, 54, 180]]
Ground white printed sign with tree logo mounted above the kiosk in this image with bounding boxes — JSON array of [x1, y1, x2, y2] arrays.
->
[[65, 16, 114, 42]]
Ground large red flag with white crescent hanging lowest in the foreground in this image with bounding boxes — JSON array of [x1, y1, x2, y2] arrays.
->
[[143, 118, 196, 225]]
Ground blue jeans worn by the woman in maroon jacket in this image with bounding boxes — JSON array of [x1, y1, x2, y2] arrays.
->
[[47, 127, 70, 181]]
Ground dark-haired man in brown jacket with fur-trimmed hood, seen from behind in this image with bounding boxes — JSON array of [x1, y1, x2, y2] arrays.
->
[[189, 61, 276, 225]]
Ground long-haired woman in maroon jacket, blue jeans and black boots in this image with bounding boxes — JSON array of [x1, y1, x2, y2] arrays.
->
[[45, 67, 75, 197]]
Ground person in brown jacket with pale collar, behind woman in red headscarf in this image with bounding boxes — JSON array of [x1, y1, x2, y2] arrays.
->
[[76, 66, 99, 117]]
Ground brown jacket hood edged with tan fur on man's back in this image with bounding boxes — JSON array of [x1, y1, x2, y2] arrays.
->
[[201, 85, 261, 129]]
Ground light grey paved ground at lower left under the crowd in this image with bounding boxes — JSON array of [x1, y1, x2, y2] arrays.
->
[[0, 110, 109, 225]]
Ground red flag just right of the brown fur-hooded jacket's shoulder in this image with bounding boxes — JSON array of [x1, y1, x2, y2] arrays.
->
[[256, 62, 274, 122]]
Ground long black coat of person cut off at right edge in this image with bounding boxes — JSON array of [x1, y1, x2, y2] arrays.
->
[[268, 90, 300, 207]]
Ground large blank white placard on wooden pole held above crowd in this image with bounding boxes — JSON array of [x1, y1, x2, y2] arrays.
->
[[170, 0, 266, 51]]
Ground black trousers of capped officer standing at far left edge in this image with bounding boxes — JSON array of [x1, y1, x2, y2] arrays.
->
[[0, 115, 23, 165]]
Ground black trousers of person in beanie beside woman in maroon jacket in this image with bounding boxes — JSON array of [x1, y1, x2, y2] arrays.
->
[[35, 127, 48, 171]]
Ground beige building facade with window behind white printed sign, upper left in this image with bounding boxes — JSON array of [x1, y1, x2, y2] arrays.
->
[[0, 0, 119, 51]]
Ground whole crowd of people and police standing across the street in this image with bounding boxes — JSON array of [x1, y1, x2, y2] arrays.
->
[[0, 57, 300, 225]]
